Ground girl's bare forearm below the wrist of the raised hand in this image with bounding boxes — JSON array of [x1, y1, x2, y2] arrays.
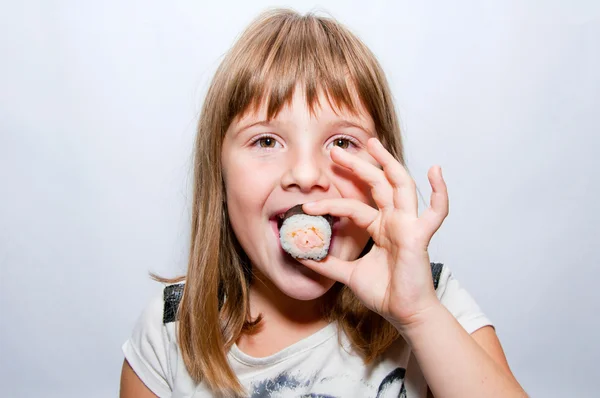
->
[[398, 303, 527, 398]]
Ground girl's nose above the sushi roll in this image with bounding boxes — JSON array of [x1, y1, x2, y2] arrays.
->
[[281, 148, 331, 193]]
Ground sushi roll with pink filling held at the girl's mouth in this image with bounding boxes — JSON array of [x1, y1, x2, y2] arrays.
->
[[279, 204, 333, 261]]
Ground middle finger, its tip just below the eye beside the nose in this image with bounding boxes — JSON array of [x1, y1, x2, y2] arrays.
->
[[330, 147, 394, 209]]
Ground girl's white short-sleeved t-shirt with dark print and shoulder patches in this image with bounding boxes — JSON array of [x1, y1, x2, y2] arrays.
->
[[123, 263, 492, 398]]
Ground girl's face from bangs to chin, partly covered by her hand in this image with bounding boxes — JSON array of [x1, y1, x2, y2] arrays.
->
[[221, 88, 377, 300]]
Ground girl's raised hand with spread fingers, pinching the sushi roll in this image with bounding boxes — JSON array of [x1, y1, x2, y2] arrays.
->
[[299, 138, 448, 332]]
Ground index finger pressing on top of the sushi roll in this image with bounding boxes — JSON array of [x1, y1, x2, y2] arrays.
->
[[302, 198, 379, 233]]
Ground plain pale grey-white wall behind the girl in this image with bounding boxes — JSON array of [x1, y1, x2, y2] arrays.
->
[[0, 0, 600, 398]]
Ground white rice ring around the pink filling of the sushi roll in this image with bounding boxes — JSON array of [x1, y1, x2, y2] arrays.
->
[[279, 214, 331, 260]]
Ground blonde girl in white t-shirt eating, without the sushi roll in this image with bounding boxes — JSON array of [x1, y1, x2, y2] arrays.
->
[[121, 10, 526, 398]]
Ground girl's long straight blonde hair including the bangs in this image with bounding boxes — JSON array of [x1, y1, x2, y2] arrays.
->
[[157, 9, 404, 396]]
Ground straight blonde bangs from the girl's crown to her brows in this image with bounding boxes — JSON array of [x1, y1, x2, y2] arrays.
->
[[227, 13, 380, 125]]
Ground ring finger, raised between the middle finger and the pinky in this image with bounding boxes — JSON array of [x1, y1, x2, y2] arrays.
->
[[367, 138, 419, 215]]
